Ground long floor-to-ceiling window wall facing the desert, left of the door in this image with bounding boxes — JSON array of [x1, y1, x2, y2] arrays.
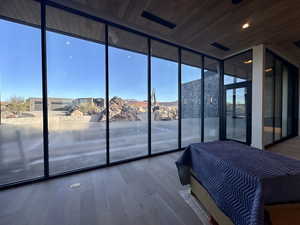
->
[[0, 0, 223, 187]]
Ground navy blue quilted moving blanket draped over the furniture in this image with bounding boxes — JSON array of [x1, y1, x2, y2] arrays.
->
[[176, 141, 300, 225]]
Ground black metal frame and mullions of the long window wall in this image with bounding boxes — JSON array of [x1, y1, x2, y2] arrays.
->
[[0, 0, 223, 190]]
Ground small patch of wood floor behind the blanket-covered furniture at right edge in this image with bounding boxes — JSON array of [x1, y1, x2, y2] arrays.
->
[[267, 137, 300, 160]]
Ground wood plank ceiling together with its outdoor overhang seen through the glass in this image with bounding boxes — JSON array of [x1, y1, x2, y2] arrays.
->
[[0, 0, 300, 65]]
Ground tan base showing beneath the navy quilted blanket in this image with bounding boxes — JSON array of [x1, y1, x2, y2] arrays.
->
[[191, 176, 300, 225]]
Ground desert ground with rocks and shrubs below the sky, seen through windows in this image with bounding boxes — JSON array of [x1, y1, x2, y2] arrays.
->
[[0, 96, 223, 183]]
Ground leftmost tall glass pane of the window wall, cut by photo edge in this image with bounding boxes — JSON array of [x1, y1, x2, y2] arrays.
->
[[0, 1, 44, 184]]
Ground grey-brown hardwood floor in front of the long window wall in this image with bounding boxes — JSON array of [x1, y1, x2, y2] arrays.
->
[[0, 152, 201, 225]]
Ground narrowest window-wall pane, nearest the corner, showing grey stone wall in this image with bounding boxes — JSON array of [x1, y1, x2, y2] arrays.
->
[[204, 57, 220, 141]]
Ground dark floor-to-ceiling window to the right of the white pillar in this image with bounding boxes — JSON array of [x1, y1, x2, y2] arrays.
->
[[264, 50, 298, 146]]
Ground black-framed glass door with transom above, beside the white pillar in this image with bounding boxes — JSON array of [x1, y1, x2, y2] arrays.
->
[[222, 50, 253, 145]]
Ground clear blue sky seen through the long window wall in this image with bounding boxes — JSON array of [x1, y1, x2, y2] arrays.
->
[[0, 20, 201, 101]]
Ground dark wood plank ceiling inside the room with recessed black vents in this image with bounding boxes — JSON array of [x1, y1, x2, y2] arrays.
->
[[50, 0, 300, 64]]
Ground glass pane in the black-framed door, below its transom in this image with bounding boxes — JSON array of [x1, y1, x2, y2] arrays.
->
[[226, 88, 247, 142]]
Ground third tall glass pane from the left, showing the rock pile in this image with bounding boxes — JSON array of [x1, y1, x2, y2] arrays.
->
[[109, 27, 148, 161]]
